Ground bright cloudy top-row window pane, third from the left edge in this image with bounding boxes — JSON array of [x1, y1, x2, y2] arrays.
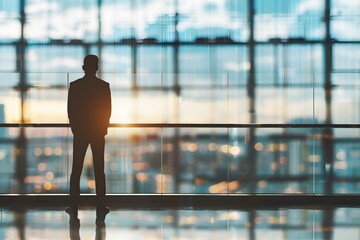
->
[[101, 0, 175, 42]]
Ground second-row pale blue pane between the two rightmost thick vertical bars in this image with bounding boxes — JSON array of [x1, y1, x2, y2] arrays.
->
[[255, 44, 324, 87]]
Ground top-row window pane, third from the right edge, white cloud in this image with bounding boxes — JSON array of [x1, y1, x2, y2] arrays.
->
[[178, 0, 249, 41]]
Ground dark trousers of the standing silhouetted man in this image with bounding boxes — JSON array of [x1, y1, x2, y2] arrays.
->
[[70, 135, 106, 201]]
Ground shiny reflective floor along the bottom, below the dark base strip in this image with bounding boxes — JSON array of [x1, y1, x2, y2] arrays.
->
[[0, 208, 360, 240]]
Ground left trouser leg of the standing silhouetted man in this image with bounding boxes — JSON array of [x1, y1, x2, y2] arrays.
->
[[70, 135, 89, 201]]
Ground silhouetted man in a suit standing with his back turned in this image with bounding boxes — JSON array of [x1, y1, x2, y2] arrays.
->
[[67, 55, 111, 221]]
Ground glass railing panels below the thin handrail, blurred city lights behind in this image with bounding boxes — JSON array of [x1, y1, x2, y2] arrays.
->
[[0, 124, 360, 195]]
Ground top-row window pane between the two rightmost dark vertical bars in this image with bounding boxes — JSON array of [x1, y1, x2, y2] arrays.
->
[[254, 0, 325, 41]]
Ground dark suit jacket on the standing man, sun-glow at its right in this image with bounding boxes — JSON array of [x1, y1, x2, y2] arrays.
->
[[67, 76, 111, 136]]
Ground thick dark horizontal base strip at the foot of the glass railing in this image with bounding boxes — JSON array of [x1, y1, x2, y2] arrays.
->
[[0, 193, 360, 210]]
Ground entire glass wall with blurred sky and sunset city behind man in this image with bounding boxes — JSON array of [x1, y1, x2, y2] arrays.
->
[[0, 0, 360, 236]]
